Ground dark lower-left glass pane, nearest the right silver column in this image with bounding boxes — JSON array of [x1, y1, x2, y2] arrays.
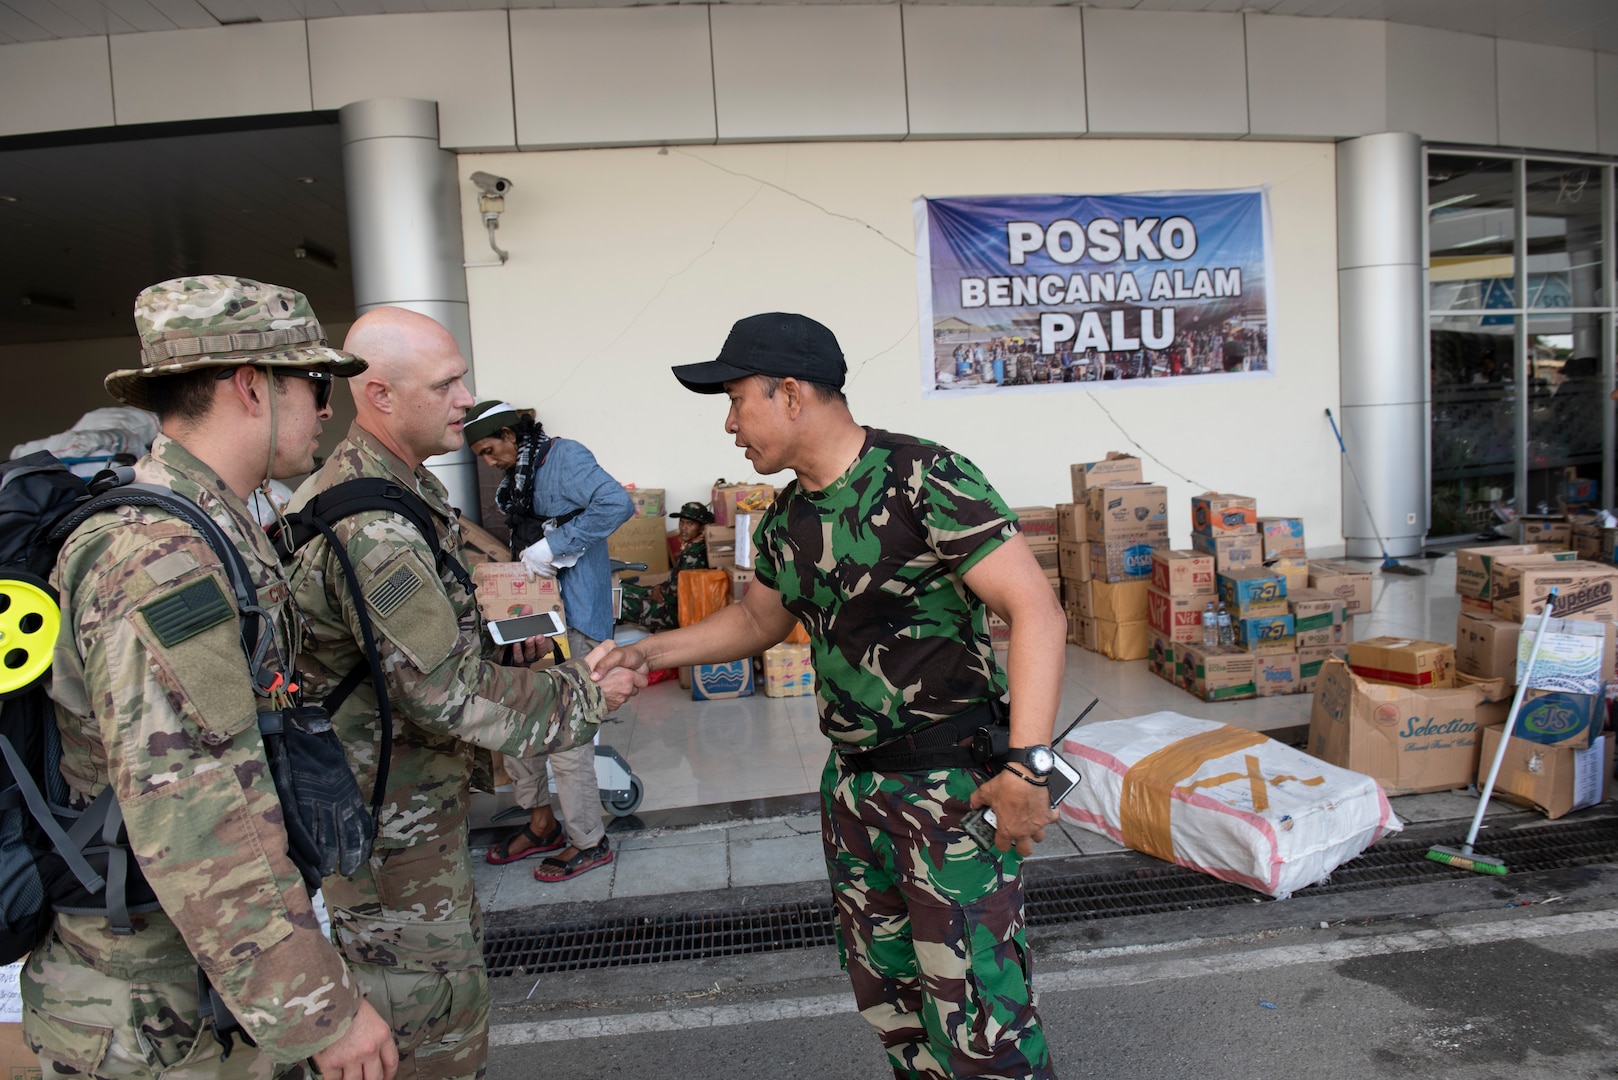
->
[[1430, 316, 1518, 536]]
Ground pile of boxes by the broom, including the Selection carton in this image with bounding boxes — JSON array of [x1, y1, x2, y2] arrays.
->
[[1309, 544, 1618, 818]]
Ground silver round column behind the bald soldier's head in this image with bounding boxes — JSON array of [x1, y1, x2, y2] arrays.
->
[[338, 97, 481, 521]]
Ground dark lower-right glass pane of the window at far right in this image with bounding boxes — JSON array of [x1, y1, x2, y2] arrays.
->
[[1524, 314, 1607, 513]]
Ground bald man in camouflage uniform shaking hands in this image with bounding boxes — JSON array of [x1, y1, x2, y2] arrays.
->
[[291, 308, 646, 1080]]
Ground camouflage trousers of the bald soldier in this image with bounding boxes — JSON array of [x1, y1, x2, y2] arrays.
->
[[324, 818, 489, 1080]]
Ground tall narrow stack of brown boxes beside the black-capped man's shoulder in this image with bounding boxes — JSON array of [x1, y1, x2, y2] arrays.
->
[[1057, 452, 1168, 661]]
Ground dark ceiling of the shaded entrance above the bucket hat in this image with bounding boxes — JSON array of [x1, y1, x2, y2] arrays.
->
[[0, 123, 354, 343]]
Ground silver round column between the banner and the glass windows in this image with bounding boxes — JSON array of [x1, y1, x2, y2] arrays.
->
[[1336, 133, 1432, 559]]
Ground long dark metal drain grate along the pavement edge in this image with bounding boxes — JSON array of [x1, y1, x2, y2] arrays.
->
[[484, 819, 1618, 976]]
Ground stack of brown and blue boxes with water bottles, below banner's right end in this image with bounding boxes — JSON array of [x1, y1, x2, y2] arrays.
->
[[1147, 491, 1370, 701]]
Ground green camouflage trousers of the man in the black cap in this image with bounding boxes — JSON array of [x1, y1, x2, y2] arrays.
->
[[820, 751, 1055, 1080]]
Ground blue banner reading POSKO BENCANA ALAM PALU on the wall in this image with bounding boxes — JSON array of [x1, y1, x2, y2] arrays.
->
[[916, 189, 1273, 397]]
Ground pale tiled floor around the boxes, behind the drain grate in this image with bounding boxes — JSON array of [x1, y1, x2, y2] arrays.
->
[[474, 559, 1519, 912]]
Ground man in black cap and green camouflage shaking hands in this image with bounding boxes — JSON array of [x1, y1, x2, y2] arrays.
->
[[597, 314, 1066, 1080]]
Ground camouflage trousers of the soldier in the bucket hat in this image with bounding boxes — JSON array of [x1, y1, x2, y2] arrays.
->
[[21, 934, 304, 1080]]
